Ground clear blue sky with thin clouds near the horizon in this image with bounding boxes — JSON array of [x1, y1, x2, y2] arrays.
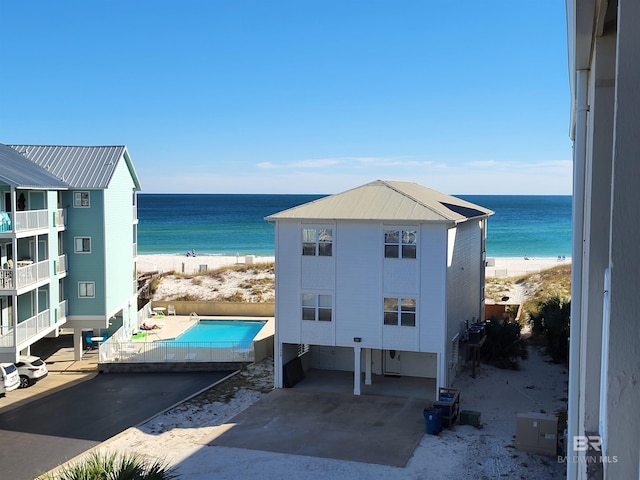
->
[[0, 0, 572, 194]]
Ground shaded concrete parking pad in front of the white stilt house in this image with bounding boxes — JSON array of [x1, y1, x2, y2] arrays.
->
[[210, 388, 425, 467]]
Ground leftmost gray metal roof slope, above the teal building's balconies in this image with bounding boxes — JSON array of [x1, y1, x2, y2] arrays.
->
[[0, 143, 69, 189]]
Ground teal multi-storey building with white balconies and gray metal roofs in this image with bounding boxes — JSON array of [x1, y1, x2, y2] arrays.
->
[[0, 144, 140, 362]]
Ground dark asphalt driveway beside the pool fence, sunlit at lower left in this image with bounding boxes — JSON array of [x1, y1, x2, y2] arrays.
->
[[0, 372, 231, 480]]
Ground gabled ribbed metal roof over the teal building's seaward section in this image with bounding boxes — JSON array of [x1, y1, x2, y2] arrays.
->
[[9, 145, 140, 189]]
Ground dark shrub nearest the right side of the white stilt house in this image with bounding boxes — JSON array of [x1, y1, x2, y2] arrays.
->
[[480, 317, 529, 370]]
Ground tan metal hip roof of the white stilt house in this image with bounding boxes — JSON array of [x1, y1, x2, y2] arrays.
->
[[266, 180, 494, 223]]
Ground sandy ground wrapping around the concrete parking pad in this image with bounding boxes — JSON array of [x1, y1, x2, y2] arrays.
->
[[86, 347, 567, 480]]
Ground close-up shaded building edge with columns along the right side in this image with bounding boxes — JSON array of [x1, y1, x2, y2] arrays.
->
[[566, 0, 640, 480]]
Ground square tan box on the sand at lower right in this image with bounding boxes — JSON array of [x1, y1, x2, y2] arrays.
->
[[516, 413, 558, 456]]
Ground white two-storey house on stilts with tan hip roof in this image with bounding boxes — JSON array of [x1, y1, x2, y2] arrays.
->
[[266, 180, 493, 398]]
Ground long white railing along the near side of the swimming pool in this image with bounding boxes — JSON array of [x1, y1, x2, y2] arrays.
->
[[100, 338, 255, 363]]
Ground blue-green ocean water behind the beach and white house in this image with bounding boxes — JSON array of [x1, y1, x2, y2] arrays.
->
[[138, 194, 571, 257]]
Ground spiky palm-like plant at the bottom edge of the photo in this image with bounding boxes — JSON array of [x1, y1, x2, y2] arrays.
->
[[39, 452, 178, 480]]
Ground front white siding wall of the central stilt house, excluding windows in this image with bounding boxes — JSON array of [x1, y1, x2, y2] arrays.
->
[[276, 221, 446, 353]]
